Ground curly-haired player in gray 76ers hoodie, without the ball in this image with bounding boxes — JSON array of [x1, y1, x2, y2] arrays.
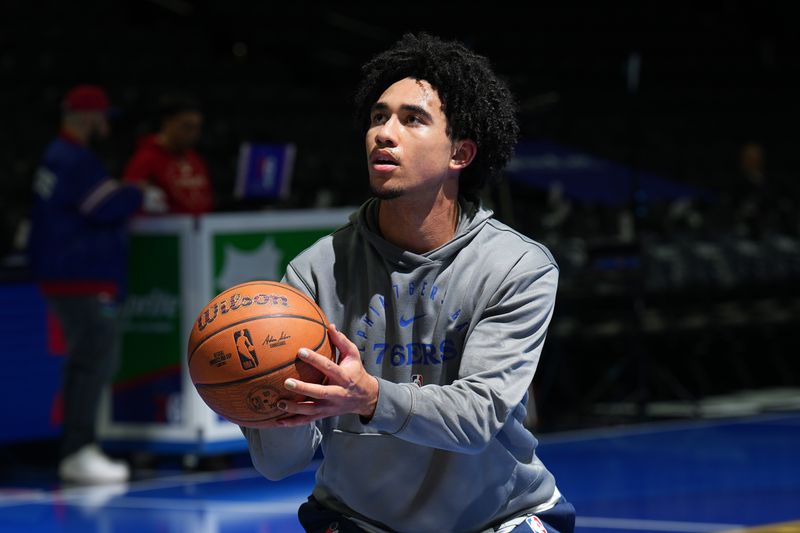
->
[[243, 34, 574, 533]]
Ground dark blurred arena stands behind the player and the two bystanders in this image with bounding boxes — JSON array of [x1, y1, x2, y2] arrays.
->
[[0, 0, 800, 427]]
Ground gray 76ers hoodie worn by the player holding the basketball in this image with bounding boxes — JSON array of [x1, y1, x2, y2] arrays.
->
[[244, 199, 560, 533]]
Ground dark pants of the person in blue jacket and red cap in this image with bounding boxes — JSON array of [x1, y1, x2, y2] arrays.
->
[[48, 295, 119, 457]]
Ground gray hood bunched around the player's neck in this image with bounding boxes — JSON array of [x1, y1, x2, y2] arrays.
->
[[350, 197, 493, 270]]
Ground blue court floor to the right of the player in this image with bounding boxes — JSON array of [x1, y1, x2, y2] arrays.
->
[[540, 415, 800, 532]]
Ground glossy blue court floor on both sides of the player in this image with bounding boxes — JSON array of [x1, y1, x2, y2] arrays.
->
[[0, 414, 800, 533]]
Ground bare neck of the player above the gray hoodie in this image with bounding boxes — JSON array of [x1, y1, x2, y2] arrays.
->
[[378, 191, 459, 253]]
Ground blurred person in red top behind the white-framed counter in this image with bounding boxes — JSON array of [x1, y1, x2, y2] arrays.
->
[[124, 97, 214, 215]]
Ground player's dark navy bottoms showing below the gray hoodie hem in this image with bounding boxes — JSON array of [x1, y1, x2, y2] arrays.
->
[[297, 496, 575, 533]]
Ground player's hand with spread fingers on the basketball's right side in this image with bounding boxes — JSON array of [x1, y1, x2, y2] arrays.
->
[[277, 324, 379, 427]]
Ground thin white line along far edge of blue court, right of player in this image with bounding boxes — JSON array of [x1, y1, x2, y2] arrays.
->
[[536, 413, 797, 444]]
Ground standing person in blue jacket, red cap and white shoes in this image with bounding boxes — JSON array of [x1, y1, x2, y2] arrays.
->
[[29, 85, 163, 483]]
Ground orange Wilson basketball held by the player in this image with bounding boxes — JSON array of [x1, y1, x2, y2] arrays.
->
[[188, 281, 336, 425]]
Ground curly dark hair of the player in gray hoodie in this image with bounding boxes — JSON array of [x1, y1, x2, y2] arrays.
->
[[356, 33, 519, 198]]
